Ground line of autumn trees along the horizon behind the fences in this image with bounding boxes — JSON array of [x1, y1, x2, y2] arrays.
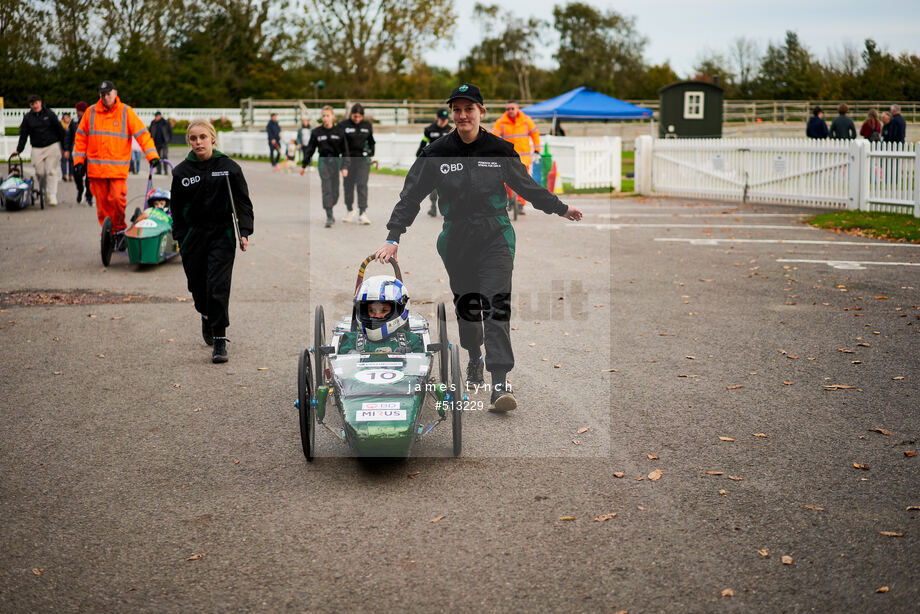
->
[[0, 0, 920, 107]]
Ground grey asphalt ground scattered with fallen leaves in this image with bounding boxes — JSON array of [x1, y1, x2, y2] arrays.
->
[[0, 163, 920, 614]]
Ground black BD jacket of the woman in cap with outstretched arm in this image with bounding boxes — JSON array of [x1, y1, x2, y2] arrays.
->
[[387, 128, 569, 241]]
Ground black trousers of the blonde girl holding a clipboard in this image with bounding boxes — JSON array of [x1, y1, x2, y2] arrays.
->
[[180, 227, 236, 337]]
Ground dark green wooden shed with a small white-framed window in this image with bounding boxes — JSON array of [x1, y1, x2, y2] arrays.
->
[[658, 81, 723, 139]]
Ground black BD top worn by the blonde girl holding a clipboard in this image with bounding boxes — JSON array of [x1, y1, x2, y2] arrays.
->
[[170, 149, 253, 244]]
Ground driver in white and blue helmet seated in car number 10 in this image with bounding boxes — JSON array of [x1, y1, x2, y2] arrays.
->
[[339, 275, 425, 354]]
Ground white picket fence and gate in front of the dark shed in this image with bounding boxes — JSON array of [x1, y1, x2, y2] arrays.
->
[[636, 136, 920, 217]]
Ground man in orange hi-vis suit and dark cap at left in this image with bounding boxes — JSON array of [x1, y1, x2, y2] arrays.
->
[[73, 81, 160, 232]]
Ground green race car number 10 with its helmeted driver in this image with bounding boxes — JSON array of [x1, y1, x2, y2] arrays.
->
[[295, 255, 467, 461]]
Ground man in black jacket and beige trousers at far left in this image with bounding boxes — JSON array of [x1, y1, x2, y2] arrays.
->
[[13, 95, 66, 207]]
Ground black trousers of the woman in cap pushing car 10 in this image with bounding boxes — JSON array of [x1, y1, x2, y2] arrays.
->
[[438, 216, 514, 373]]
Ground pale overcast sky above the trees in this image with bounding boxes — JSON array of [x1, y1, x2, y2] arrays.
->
[[426, 0, 920, 77]]
